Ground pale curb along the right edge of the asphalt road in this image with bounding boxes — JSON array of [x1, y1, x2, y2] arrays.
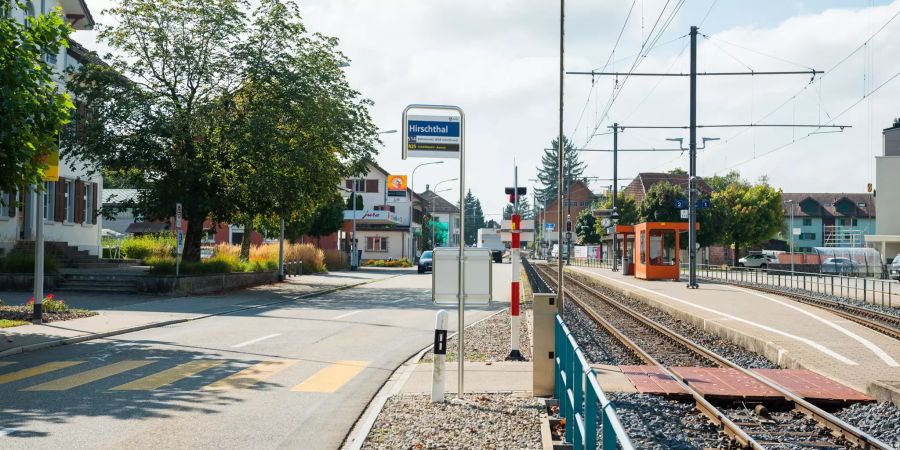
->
[[340, 308, 506, 450]]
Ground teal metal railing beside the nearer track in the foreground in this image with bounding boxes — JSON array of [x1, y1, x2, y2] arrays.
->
[[555, 315, 634, 450]]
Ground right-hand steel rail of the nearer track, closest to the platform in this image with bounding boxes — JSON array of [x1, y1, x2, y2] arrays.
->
[[536, 264, 892, 450]]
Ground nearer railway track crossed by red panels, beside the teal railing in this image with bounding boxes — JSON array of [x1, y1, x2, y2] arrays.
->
[[536, 265, 891, 450]]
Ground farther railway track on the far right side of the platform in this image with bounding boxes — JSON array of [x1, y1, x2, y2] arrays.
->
[[701, 277, 900, 340]]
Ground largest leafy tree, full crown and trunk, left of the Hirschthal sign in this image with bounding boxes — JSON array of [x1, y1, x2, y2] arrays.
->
[[71, 0, 377, 260]]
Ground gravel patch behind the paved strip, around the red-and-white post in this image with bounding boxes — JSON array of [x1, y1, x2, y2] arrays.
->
[[420, 305, 531, 362]]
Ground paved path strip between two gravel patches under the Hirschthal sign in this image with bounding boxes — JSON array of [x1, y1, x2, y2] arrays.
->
[[400, 361, 532, 393]]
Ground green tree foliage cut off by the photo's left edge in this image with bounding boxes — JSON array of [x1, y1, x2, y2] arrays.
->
[[0, 0, 74, 193]]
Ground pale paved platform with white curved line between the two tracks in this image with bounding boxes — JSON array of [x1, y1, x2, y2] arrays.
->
[[569, 267, 900, 392]]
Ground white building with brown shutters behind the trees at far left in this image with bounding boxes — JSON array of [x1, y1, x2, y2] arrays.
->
[[0, 0, 103, 256]]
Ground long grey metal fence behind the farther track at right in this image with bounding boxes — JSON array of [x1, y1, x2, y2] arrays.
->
[[681, 264, 900, 306]]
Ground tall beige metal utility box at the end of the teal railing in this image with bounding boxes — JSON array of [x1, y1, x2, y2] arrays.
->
[[531, 293, 557, 397]]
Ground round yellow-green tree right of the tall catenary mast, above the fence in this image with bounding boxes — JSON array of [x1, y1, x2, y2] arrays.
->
[[712, 183, 784, 265]]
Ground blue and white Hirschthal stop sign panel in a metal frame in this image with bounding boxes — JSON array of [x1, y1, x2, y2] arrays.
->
[[403, 115, 462, 159]]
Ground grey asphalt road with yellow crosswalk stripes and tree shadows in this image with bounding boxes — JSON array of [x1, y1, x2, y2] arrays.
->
[[0, 265, 509, 449]]
